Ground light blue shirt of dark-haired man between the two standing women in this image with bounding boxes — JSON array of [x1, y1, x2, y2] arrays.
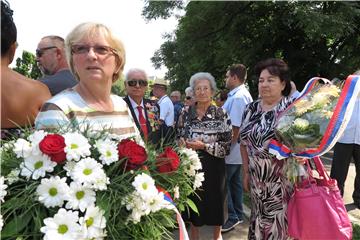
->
[[222, 84, 253, 164]]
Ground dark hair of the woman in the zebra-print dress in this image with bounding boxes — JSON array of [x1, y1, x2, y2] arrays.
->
[[255, 58, 291, 96]]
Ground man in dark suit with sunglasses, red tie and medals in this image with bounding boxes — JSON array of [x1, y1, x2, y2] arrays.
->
[[124, 68, 161, 145]]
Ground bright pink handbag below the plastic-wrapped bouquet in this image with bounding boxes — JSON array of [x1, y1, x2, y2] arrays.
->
[[287, 157, 352, 240]]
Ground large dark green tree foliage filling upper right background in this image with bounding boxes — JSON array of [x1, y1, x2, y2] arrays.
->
[[144, 1, 360, 96]]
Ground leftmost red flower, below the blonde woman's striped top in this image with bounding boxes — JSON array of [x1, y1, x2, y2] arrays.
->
[[39, 134, 66, 163]]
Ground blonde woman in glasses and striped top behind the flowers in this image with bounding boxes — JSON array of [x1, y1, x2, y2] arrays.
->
[[35, 23, 139, 137]]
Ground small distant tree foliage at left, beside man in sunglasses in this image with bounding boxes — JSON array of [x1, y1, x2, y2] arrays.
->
[[13, 51, 42, 79]]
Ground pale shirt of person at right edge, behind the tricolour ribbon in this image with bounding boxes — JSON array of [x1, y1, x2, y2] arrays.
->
[[338, 95, 360, 145]]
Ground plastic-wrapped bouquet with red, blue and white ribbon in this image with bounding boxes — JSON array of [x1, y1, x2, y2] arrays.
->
[[269, 75, 360, 159]]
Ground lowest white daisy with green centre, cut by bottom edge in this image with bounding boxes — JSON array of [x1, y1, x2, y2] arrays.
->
[[40, 208, 81, 240]]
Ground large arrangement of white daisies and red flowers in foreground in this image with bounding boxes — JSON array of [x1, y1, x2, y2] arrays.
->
[[0, 126, 203, 240]]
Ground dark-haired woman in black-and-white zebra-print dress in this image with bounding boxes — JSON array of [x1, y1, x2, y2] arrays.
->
[[240, 59, 300, 240]]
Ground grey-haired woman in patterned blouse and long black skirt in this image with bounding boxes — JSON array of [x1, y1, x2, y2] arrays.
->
[[177, 72, 231, 239]]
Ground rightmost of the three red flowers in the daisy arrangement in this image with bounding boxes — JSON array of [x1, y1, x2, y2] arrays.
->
[[156, 147, 180, 173]]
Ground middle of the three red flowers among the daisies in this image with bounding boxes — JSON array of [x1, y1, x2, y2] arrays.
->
[[118, 139, 147, 170]]
